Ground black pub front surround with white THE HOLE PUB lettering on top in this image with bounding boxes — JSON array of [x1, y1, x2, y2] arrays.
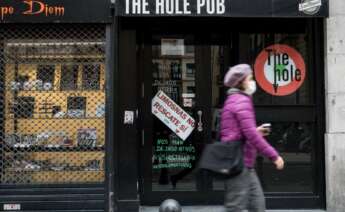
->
[[116, 0, 328, 211]]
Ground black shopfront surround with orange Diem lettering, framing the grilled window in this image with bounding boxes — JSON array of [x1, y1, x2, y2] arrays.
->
[[0, 0, 116, 212]]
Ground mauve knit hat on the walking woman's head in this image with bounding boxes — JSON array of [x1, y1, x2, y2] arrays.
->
[[224, 64, 253, 88]]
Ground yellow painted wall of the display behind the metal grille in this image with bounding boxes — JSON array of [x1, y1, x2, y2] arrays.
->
[[2, 63, 105, 183]]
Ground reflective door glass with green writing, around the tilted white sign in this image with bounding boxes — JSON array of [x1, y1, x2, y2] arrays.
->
[[152, 36, 198, 191]]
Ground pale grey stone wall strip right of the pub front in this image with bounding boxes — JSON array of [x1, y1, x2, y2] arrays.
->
[[325, 0, 345, 212]]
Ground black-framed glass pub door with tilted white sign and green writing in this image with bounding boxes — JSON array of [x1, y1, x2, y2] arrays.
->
[[139, 34, 211, 203]]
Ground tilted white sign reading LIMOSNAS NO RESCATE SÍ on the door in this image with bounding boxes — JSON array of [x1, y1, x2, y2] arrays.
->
[[152, 91, 195, 140]]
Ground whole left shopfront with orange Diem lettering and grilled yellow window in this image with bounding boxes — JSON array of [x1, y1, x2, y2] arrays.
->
[[0, 1, 112, 211]]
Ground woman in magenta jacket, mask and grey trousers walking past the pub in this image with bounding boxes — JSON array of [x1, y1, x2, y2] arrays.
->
[[220, 64, 284, 212]]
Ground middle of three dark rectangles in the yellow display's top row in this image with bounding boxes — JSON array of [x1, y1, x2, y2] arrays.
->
[[60, 65, 79, 90]]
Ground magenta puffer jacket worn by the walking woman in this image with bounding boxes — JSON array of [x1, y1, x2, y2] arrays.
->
[[220, 91, 279, 168]]
